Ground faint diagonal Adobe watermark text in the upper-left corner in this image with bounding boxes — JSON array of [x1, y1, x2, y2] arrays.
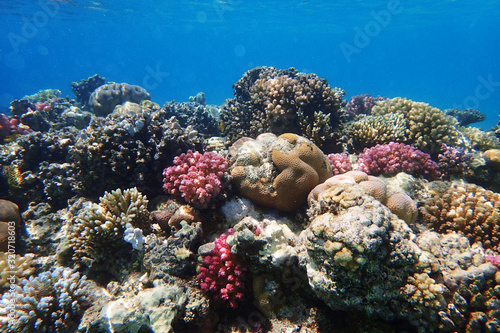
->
[[7, 0, 59, 53]]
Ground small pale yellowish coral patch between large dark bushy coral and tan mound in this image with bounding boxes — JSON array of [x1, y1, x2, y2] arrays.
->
[[344, 113, 406, 148]]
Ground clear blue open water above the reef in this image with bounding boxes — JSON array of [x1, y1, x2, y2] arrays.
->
[[0, 0, 500, 129]]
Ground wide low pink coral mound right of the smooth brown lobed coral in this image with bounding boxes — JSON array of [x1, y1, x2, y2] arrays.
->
[[358, 142, 441, 179]]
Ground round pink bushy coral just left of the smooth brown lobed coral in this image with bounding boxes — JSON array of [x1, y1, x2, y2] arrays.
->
[[163, 150, 228, 209]]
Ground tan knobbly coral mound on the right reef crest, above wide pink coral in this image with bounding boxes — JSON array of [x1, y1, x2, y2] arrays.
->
[[372, 97, 462, 153]]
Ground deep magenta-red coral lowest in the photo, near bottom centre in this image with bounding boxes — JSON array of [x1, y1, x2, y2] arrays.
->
[[198, 229, 246, 308]]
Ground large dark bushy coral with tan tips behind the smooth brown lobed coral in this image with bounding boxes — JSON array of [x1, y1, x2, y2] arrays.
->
[[220, 67, 345, 147]]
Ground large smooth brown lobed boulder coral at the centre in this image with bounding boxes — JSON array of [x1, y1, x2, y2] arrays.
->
[[230, 133, 332, 211]]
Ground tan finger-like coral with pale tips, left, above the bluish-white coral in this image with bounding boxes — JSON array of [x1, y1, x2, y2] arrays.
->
[[59, 188, 150, 267]]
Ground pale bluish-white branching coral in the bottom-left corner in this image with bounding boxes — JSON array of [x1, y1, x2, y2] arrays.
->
[[0, 267, 91, 333]]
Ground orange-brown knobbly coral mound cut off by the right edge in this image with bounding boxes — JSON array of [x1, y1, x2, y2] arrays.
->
[[420, 184, 500, 251]]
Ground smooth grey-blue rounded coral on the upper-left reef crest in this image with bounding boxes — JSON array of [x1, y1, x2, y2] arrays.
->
[[88, 83, 151, 116]]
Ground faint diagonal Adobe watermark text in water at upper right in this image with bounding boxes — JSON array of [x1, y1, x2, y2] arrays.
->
[[339, 0, 403, 64]]
